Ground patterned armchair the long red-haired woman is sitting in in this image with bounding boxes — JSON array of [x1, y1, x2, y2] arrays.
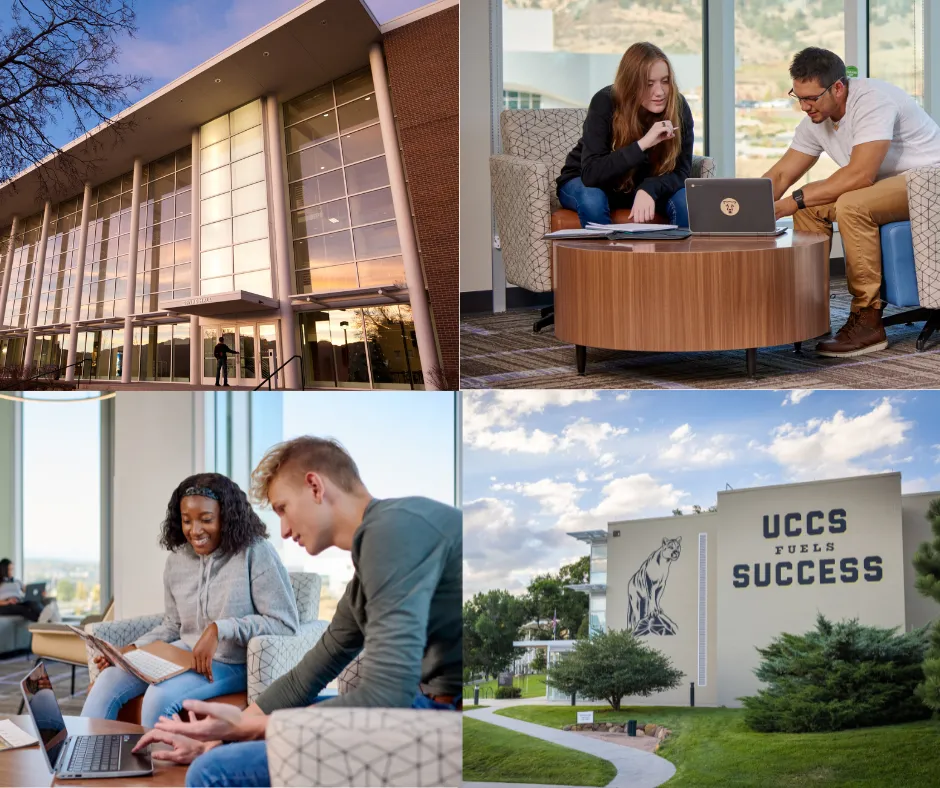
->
[[490, 109, 715, 293]]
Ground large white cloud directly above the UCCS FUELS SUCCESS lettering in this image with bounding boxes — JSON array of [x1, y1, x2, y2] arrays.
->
[[759, 398, 914, 480]]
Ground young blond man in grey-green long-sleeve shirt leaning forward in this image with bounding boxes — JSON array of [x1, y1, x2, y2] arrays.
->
[[138, 437, 463, 786]]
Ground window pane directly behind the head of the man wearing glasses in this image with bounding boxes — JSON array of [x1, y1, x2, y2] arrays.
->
[[734, 0, 854, 194]]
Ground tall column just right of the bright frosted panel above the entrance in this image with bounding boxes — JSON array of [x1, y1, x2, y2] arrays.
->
[[258, 94, 300, 389]]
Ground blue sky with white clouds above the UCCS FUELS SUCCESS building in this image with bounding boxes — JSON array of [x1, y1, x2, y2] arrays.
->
[[463, 391, 940, 597]]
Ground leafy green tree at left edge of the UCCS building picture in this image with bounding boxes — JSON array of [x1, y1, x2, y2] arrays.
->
[[463, 590, 525, 676]]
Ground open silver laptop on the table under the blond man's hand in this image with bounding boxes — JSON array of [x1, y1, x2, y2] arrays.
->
[[20, 662, 153, 780]]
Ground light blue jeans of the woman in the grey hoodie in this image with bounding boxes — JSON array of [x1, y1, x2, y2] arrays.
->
[[82, 640, 248, 728]]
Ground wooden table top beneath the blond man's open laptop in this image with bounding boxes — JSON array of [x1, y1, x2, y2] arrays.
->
[[0, 714, 186, 786]]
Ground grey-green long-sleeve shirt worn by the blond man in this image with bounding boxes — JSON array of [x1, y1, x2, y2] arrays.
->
[[256, 498, 463, 714]]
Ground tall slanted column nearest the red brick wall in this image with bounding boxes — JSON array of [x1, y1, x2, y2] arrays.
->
[[369, 44, 441, 391]]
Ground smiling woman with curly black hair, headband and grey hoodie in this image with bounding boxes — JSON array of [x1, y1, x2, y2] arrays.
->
[[82, 473, 298, 728]]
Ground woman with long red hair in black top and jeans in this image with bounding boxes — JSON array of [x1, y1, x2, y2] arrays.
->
[[558, 42, 694, 227]]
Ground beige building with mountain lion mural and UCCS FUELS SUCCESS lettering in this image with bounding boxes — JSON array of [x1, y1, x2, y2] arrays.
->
[[556, 473, 940, 706]]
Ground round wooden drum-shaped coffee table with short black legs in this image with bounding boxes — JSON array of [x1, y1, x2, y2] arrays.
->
[[552, 230, 829, 375]]
